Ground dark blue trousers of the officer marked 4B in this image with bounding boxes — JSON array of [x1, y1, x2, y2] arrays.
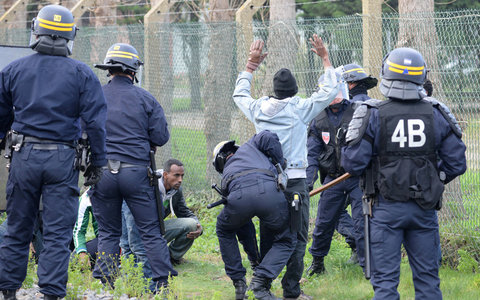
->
[[370, 199, 442, 300]]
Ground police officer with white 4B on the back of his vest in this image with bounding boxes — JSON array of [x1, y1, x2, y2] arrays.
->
[[342, 48, 466, 299]]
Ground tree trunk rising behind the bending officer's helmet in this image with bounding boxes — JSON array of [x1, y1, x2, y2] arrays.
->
[[204, 0, 236, 183]]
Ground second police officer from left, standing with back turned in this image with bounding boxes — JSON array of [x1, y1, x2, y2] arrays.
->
[[91, 43, 177, 288]]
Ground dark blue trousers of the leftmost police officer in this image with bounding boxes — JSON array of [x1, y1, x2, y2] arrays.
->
[[0, 143, 79, 297]]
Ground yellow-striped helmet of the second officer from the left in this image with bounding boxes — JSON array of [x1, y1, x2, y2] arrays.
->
[[94, 43, 143, 73]]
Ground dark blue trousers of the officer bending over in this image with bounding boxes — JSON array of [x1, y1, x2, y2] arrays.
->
[[217, 178, 295, 280]]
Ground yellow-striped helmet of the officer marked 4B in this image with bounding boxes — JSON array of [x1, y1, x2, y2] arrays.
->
[[380, 48, 427, 100]]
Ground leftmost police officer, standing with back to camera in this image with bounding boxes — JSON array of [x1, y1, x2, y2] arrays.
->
[[0, 5, 106, 299]]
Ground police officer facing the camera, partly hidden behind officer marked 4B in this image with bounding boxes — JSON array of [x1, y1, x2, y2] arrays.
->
[[307, 77, 363, 276]]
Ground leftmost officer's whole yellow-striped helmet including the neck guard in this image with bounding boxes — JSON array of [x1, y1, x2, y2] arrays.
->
[[30, 5, 78, 56]]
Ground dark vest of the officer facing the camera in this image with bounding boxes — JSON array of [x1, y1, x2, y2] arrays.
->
[[315, 104, 354, 182]]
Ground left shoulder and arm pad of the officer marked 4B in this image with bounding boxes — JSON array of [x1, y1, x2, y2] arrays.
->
[[346, 99, 381, 145]]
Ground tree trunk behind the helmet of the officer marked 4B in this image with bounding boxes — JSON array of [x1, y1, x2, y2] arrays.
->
[[397, 0, 467, 220]]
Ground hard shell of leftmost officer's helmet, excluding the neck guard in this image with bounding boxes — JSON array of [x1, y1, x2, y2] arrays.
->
[[32, 5, 77, 41]]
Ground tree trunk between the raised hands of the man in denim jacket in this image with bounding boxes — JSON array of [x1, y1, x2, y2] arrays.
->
[[262, 0, 298, 95]]
